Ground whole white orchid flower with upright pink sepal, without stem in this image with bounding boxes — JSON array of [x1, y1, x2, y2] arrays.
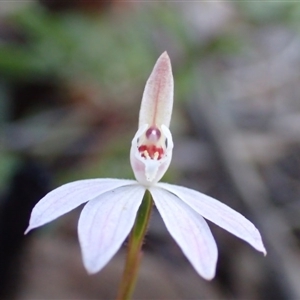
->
[[26, 53, 266, 279]]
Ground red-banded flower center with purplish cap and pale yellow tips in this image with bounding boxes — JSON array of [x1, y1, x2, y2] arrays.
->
[[138, 126, 164, 160]]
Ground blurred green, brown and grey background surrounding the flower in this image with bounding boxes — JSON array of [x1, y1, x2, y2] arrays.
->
[[0, 0, 300, 300]]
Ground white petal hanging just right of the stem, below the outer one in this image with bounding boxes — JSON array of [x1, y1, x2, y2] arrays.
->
[[149, 187, 218, 280]]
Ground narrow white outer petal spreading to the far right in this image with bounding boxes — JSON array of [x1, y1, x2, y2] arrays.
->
[[158, 183, 266, 254]]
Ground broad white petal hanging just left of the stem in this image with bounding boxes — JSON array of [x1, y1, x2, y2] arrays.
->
[[78, 184, 145, 274]]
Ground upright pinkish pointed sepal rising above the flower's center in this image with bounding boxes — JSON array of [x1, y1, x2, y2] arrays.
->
[[139, 52, 174, 127]]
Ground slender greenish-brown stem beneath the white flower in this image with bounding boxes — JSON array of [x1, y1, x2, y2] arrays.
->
[[117, 190, 153, 300]]
